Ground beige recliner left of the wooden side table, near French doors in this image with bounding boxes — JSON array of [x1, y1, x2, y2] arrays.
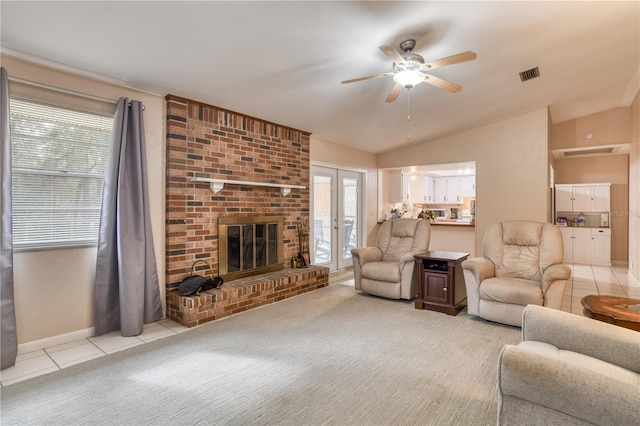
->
[[351, 219, 431, 300]]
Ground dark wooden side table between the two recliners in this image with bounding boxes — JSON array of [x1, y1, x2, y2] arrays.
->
[[414, 250, 469, 315]]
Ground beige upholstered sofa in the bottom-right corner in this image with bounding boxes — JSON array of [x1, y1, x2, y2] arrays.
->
[[497, 305, 640, 426]]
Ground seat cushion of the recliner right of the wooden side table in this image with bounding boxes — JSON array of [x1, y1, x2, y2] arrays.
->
[[480, 277, 544, 306]]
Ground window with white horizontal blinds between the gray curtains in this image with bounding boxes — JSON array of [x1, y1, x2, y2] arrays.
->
[[10, 98, 113, 249]]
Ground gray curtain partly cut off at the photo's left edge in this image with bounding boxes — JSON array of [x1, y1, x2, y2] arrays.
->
[[0, 68, 18, 368]]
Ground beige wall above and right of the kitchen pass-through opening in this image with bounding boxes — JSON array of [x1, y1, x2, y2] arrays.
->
[[378, 108, 550, 254]]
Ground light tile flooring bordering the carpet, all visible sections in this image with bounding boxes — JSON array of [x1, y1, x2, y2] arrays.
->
[[0, 264, 640, 386]]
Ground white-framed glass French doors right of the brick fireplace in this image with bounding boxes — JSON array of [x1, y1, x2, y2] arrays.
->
[[311, 166, 363, 271]]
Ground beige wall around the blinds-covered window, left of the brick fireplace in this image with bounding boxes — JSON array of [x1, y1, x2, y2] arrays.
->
[[2, 55, 165, 346]]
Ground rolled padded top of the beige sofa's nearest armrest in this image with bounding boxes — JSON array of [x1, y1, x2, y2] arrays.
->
[[498, 344, 640, 425]]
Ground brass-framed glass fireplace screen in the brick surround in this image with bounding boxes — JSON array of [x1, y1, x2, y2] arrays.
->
[[218, 216, 284, 281]]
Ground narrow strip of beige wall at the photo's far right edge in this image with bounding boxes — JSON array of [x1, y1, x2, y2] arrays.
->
[[629, 91, 640, 280]]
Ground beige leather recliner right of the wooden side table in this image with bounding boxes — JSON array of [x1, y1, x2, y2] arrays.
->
[[462, 220, 571, 327]]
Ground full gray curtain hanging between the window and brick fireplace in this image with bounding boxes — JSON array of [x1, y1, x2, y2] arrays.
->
[[94, 98, 163, 336]]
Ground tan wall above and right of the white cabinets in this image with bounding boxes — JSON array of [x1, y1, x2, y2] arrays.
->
[[555, 155, 629, 264]]
